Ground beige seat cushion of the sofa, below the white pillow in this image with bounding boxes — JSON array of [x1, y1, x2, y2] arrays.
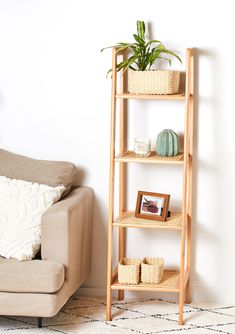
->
[[0, 257, 64, 293]]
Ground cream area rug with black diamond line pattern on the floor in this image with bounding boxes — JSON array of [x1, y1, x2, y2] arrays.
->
[[0, 296, 235, 334]]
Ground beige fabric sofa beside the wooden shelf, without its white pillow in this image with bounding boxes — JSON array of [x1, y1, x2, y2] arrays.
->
[[0, 149, 93, 327]]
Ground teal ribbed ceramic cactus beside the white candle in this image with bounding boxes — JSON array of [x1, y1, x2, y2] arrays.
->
[[156, 129, 179, 157]]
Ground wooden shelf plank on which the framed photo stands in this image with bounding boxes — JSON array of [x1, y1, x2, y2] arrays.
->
[[113, 211, 182, 230]]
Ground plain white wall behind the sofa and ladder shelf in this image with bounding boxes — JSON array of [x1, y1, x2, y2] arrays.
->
[[0, 0, 235, 303]]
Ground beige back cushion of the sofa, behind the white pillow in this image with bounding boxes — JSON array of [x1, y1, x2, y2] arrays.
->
[[0, 149, 76, 196]]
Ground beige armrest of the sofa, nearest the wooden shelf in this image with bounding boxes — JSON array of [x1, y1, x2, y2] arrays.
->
[[41, 187, 93, 293]]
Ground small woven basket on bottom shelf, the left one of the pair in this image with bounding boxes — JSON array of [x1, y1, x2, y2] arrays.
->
[[118, 259, 141, 284]]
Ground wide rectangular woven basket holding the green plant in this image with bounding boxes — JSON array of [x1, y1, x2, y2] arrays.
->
[[128, 70, 180, 95]]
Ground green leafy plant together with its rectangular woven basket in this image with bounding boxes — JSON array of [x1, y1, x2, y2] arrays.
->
[[101, 21, 181, 94]]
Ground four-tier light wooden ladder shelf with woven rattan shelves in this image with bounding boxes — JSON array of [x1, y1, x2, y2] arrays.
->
[[106, 48, 194, 325]]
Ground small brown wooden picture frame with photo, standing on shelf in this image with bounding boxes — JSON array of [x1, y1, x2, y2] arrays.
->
[[135, 191, 170, 222]]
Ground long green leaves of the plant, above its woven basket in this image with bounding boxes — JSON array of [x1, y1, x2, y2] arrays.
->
[[101, 21, 182, 73]]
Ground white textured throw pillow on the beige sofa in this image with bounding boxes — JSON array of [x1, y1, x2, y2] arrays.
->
[[0, 176, 65, 260]]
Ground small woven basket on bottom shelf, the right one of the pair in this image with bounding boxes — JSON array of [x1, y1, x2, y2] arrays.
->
[[141, 257, 164, 284]]
